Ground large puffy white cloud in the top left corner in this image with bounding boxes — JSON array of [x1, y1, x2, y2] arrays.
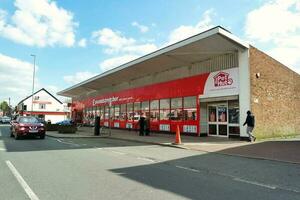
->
[[0, 0, 77, 47]]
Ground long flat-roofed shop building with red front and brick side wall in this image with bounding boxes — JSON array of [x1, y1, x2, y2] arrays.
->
[[58, 26, 300, 138]]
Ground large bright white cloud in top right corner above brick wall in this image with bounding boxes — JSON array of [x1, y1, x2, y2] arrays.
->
[[245, 0, 300, 73]]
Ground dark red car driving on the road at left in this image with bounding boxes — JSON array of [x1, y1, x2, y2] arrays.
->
[[10, 116, 46, 140]]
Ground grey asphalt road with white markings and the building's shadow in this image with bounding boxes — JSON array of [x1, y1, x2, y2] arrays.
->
[[0, 125, 300, 200]]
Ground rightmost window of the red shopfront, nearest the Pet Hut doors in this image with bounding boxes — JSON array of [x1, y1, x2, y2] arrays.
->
[[183, 96, 197, 120]]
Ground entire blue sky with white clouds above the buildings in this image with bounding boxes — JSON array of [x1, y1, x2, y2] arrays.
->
[[0, 0, 300, 105]]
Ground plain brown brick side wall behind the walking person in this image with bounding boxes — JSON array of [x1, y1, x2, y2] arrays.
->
[[249, 47, 300, 137]]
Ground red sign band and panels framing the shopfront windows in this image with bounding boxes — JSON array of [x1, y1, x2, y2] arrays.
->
[[72, 73, 209, 135]]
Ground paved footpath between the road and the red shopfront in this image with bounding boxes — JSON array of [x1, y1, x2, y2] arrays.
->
[[46, 127, 300, 164]]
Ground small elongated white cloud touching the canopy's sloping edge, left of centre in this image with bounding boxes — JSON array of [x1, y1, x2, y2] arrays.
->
[[99, 54, 139, 71]]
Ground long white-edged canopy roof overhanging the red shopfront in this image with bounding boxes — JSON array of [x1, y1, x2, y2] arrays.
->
[[57, 26, 249, 97]]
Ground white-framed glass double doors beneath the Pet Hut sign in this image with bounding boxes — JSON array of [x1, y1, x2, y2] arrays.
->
[[207, 102, 228, 137]]
